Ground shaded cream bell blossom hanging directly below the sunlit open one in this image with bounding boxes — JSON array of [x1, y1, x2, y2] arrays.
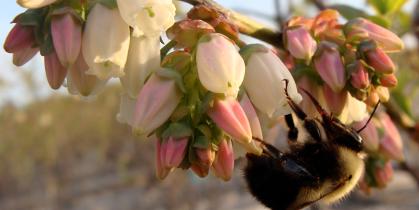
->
[[120, 36, 160, 98]]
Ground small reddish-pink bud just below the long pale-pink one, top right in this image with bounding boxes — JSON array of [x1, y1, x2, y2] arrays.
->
[[365, 48, 396, 74]]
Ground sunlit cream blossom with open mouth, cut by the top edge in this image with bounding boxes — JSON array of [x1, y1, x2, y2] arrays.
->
[[117, 0, 176, 37]]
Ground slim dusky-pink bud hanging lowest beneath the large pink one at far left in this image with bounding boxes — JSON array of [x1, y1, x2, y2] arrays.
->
[[44, 52, 67, 89]]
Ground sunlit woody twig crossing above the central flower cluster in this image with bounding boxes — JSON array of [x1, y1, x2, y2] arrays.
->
[[180, 0, 282, 47]]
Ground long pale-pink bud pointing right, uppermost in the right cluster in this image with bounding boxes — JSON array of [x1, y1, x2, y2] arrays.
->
[[344, 18, 404, 52]]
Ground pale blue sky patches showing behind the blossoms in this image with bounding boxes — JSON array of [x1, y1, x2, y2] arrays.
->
[[0, 0, 414, 106]]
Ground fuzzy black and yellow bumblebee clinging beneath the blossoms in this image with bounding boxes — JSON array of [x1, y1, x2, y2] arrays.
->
[[244, 81, 378, 210]]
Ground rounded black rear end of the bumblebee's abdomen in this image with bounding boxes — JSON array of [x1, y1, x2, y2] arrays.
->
[[244, 154, 301, 210]]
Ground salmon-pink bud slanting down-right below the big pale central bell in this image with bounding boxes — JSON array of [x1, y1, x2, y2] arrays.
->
[[207, 98, 252, 144]]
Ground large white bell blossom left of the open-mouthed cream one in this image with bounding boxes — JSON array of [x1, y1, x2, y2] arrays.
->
[[82, 4, 130, 80]]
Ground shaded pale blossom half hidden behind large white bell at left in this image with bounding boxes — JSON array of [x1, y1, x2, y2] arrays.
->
[[67, 53, 107, 96]]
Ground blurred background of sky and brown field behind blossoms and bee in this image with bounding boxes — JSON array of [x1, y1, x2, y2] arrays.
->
[[0, 0, 419, 210]]
